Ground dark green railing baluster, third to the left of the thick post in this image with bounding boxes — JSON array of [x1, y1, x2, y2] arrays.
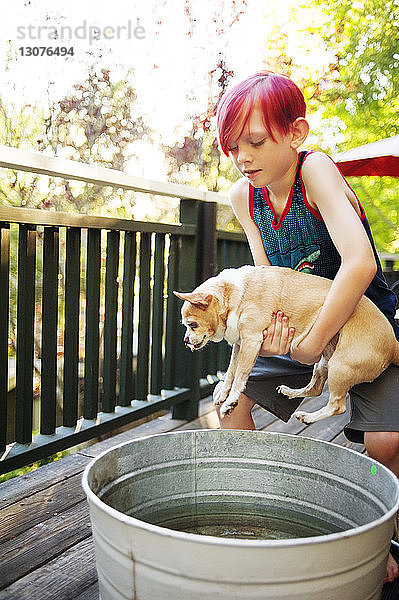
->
[[137, 233, 151, 400]]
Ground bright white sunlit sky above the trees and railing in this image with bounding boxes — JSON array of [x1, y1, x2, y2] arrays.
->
[[0, 0, 334, 179]]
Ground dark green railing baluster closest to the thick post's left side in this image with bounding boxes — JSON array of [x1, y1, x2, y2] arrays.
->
[[164, 235, 183, 390]]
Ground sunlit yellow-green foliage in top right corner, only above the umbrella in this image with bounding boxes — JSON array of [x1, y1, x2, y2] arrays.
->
[[315, 0, 399, 144]]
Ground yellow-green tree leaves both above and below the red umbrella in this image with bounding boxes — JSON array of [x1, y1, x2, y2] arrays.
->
[[304, 0, 399, 252]]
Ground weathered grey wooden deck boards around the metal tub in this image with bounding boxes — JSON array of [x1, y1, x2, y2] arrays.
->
[[0, 397, 399, 600]]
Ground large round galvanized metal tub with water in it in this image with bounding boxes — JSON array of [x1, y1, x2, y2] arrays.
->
[[83, 430, 399, 600]]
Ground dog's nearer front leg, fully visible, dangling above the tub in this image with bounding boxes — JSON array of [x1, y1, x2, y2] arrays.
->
[[220, 333, 263, 417]]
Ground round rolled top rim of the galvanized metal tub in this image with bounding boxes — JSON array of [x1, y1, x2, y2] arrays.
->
[[82, 429, 399, 548]]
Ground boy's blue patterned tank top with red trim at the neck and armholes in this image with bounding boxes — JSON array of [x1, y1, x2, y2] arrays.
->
[[249, 151, 399, 339]]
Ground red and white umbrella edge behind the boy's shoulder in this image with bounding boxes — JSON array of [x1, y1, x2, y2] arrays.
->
[[334, 135, 399, 177]]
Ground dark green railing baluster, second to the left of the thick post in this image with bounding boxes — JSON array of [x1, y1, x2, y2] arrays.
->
[[150, 233, 165, 394]]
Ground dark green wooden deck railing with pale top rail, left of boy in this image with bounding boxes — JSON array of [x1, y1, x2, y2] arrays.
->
[[0, 148, 251, 473]]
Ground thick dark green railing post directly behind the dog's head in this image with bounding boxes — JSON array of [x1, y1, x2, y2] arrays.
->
[[172, 200, 216, 420]]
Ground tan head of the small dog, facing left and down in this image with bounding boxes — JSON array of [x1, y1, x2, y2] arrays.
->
[[173, 291, 223, 352]]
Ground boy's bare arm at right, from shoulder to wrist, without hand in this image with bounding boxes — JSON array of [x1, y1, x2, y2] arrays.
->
[[292, 153, 377, 364]]
